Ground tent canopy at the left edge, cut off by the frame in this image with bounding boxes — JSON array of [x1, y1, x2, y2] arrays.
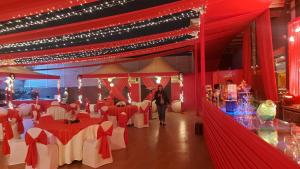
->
[[0, 66, 60, 79]]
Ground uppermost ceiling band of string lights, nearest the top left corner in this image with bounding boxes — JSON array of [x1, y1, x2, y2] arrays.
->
[[0, 0, 135, 35]]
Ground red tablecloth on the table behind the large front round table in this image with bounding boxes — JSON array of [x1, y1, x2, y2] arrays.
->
[[108, 105, 138, 118]]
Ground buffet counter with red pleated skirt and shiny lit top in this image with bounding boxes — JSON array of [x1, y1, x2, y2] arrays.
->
[[202, 100, 300, 169]]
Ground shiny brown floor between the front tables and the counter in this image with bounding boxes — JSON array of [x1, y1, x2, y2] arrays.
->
[[0, 113, 213, 169]]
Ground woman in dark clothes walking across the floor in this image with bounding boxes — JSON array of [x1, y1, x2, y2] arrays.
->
[[154, 85, 170, 126]]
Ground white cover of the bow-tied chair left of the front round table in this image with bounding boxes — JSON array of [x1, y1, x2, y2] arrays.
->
[[25, 128, 58, 169]]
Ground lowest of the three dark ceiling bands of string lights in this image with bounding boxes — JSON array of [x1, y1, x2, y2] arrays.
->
[[14, 34, 194, 64]]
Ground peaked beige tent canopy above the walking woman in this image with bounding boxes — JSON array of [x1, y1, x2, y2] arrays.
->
[[131, 57, 179, 77]]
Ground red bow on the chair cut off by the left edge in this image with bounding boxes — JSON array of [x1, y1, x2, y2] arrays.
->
[[2, 121, 13, 155]]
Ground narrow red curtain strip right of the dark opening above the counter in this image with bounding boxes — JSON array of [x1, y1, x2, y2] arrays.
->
[[243, 26, 253, 86]]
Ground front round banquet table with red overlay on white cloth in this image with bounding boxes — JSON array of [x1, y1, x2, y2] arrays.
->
[[36, 118, 103, 166]]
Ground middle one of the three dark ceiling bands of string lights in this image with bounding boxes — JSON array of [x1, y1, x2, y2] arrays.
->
[[0, 10, 199, 54]]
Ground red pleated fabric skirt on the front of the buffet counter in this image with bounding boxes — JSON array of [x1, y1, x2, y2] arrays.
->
[[202, 100, 299, 169]]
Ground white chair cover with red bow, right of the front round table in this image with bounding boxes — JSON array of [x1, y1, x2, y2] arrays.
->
[[82, 121, 113, 168]]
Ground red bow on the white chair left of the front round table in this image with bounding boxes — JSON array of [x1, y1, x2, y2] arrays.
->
[[25, 131, 48, 168]]
